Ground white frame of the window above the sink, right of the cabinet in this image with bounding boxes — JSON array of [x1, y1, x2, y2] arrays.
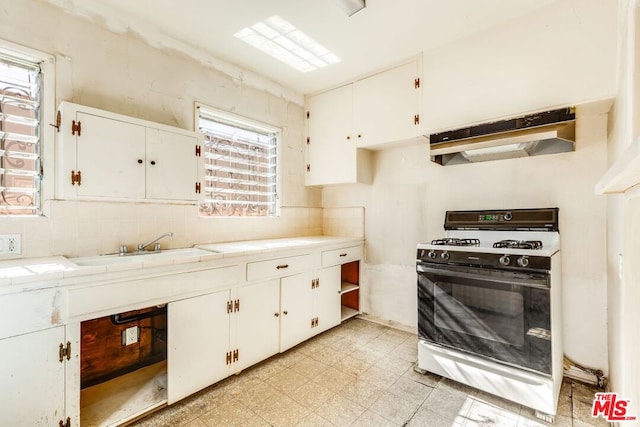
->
[[193, 102, 284, 219]]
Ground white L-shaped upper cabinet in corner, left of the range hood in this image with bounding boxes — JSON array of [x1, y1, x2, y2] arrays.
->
[[306, 56, 424, 185]]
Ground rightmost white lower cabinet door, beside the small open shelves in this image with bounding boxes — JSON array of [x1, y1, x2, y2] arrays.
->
[[313, 266, 340, 334]]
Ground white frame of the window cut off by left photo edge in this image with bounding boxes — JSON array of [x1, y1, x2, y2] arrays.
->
[[0, 39, 56, 218]]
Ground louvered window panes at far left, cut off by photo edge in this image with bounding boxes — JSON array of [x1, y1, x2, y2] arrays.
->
[[0, 52, 41, 215]]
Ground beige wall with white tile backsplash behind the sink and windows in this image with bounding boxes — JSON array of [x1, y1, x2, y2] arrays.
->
[[0, 0, 322, 256]]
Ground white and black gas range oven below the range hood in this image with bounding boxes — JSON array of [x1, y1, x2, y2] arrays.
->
[[416, 208, 562, 420]]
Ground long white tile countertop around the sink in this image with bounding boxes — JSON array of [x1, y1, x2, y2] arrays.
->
[[0, 236, 364, 294]]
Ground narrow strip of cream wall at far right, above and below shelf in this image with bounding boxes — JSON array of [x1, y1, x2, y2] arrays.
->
[[606, 0, 640, 424]]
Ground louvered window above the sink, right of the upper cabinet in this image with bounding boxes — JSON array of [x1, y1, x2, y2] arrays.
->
[[197, 105, 280, 216]]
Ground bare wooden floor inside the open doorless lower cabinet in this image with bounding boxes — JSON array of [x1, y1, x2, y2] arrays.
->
[[80, 361, 167, 426]]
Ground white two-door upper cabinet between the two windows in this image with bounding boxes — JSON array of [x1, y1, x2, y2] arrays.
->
[[56, 102, 202, 202]]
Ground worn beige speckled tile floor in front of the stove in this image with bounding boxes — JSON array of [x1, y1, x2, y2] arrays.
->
[[135, 319, 607, 427]]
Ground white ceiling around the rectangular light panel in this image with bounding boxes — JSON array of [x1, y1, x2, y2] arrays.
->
[[47, 0, 558, 94]]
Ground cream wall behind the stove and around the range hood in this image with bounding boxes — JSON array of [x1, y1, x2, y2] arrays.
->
[[323, 0, 617, 372]]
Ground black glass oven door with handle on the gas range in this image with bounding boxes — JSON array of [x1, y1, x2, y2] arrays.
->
[[417, 262, 551, 375]]
